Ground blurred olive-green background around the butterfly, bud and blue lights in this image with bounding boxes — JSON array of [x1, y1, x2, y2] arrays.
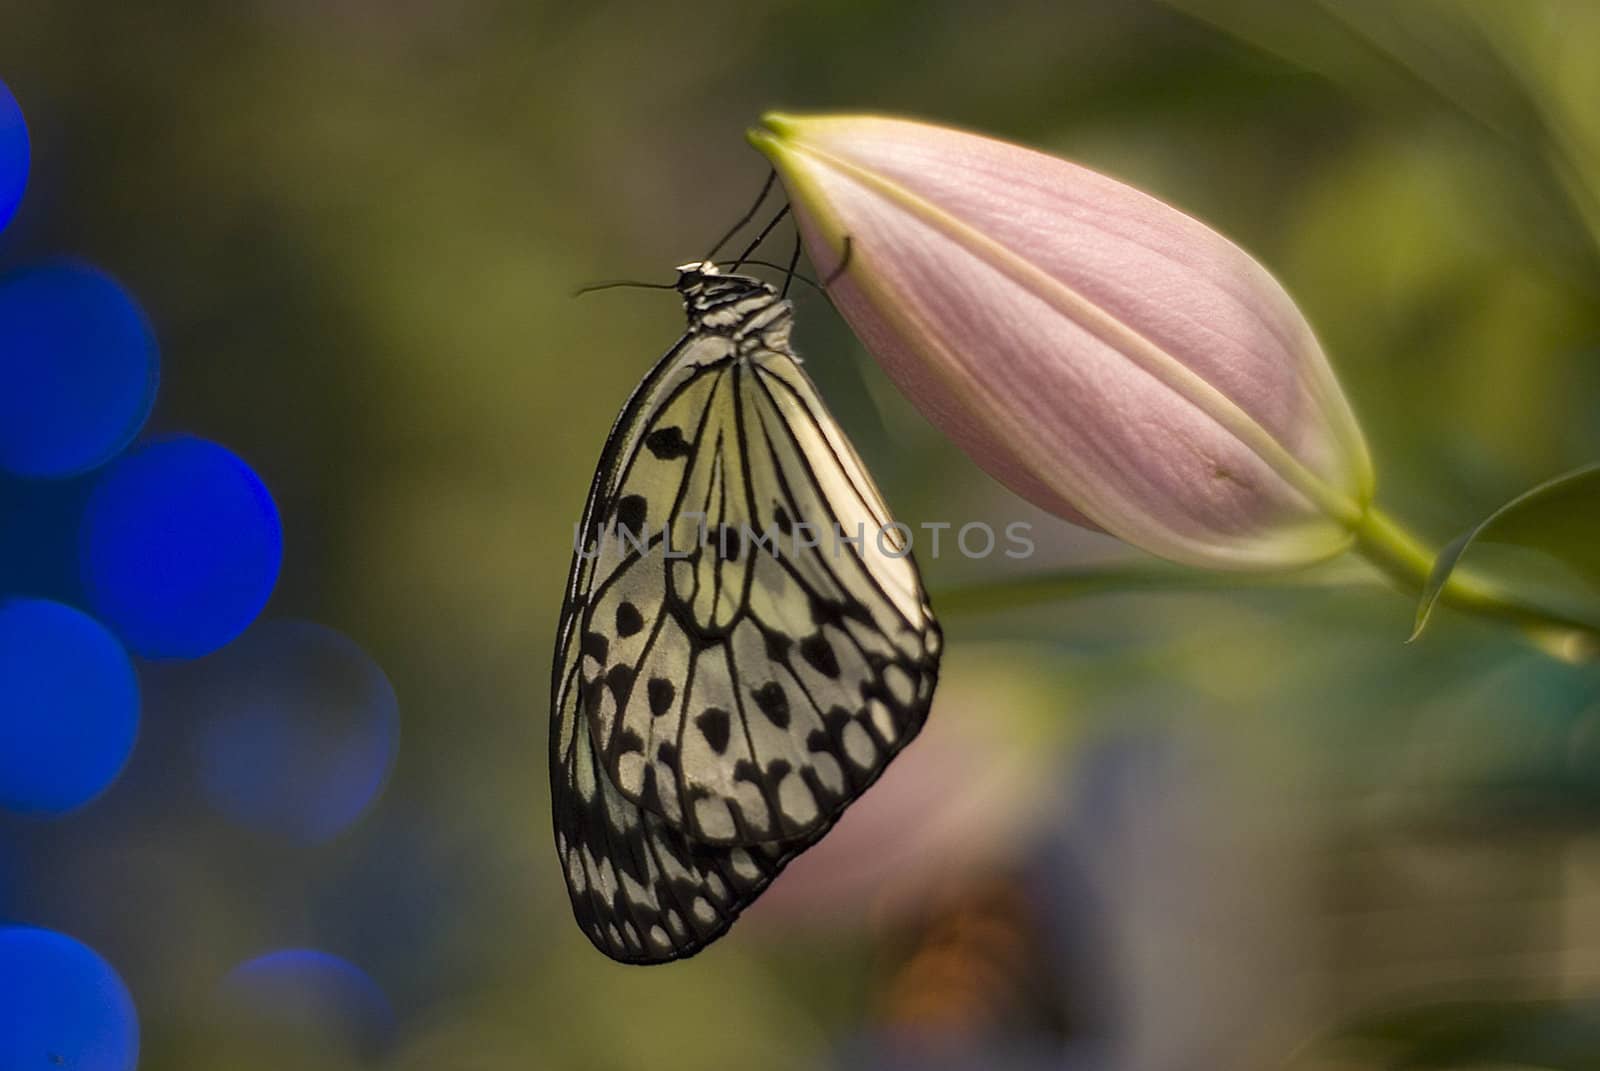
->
[[0, 0, 1600, 1071]]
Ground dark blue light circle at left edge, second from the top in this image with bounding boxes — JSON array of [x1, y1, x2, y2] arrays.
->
[[0, 260, 158, 477]]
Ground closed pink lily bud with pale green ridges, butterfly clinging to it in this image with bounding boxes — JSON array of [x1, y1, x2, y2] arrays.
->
[[750, 114, 1373, 570]]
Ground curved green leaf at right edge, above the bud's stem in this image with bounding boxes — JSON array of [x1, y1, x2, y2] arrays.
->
[[1411, 464, 1600, 639]]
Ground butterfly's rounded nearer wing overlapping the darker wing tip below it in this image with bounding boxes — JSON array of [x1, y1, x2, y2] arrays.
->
[[581, 351, 939, 844]]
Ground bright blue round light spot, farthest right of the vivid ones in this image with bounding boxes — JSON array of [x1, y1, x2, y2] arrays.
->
[[82, 435, 283, 658]]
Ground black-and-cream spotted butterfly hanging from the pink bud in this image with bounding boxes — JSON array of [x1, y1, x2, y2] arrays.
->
[[550, 261, 942, 964]]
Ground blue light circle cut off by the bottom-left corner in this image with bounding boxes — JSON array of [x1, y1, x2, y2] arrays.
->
[[0, 927, 139, 1071]]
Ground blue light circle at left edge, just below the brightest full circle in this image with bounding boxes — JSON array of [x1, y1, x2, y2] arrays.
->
[[0, 599, 139, 813]]
